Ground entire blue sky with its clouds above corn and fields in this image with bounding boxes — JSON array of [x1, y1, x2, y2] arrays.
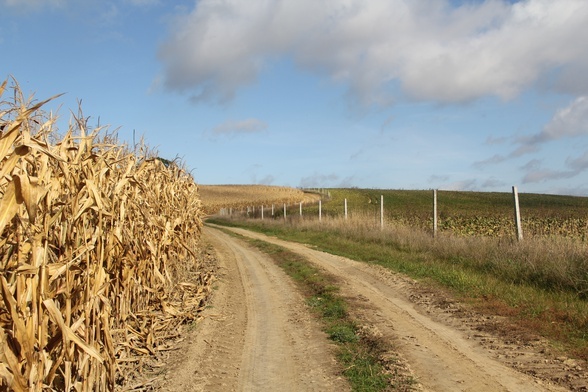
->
[[0, 0, 588, 195]]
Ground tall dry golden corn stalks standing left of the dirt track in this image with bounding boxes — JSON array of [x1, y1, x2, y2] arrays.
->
[[0, 81, 213, 391]]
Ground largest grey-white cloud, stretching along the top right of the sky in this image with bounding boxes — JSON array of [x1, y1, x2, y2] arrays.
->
[[159, 0, 588, 106]]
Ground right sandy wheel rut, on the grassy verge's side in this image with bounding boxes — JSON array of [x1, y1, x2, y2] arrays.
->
[[218, 224, 566, 392]]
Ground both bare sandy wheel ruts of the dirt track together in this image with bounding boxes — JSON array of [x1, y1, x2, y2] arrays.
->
[[166, 228, 588, 391]]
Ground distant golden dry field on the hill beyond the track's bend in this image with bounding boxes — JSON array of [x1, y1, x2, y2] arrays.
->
[[199, 185, 317, 215]]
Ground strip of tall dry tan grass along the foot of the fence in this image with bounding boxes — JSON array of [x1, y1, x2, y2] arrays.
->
[[252, 213, 588, 298]]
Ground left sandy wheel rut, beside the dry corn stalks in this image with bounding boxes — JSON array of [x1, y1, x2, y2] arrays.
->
[[162, 228, 350, 392]]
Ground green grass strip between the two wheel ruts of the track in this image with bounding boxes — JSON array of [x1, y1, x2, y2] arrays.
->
[[218, 230, 415, 392]]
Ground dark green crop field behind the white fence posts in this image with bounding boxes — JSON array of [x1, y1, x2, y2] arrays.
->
[[296, 188, 588, 240]]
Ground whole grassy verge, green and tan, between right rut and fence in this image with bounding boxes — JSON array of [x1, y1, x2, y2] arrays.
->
[[209, 219, 588, 360]]
